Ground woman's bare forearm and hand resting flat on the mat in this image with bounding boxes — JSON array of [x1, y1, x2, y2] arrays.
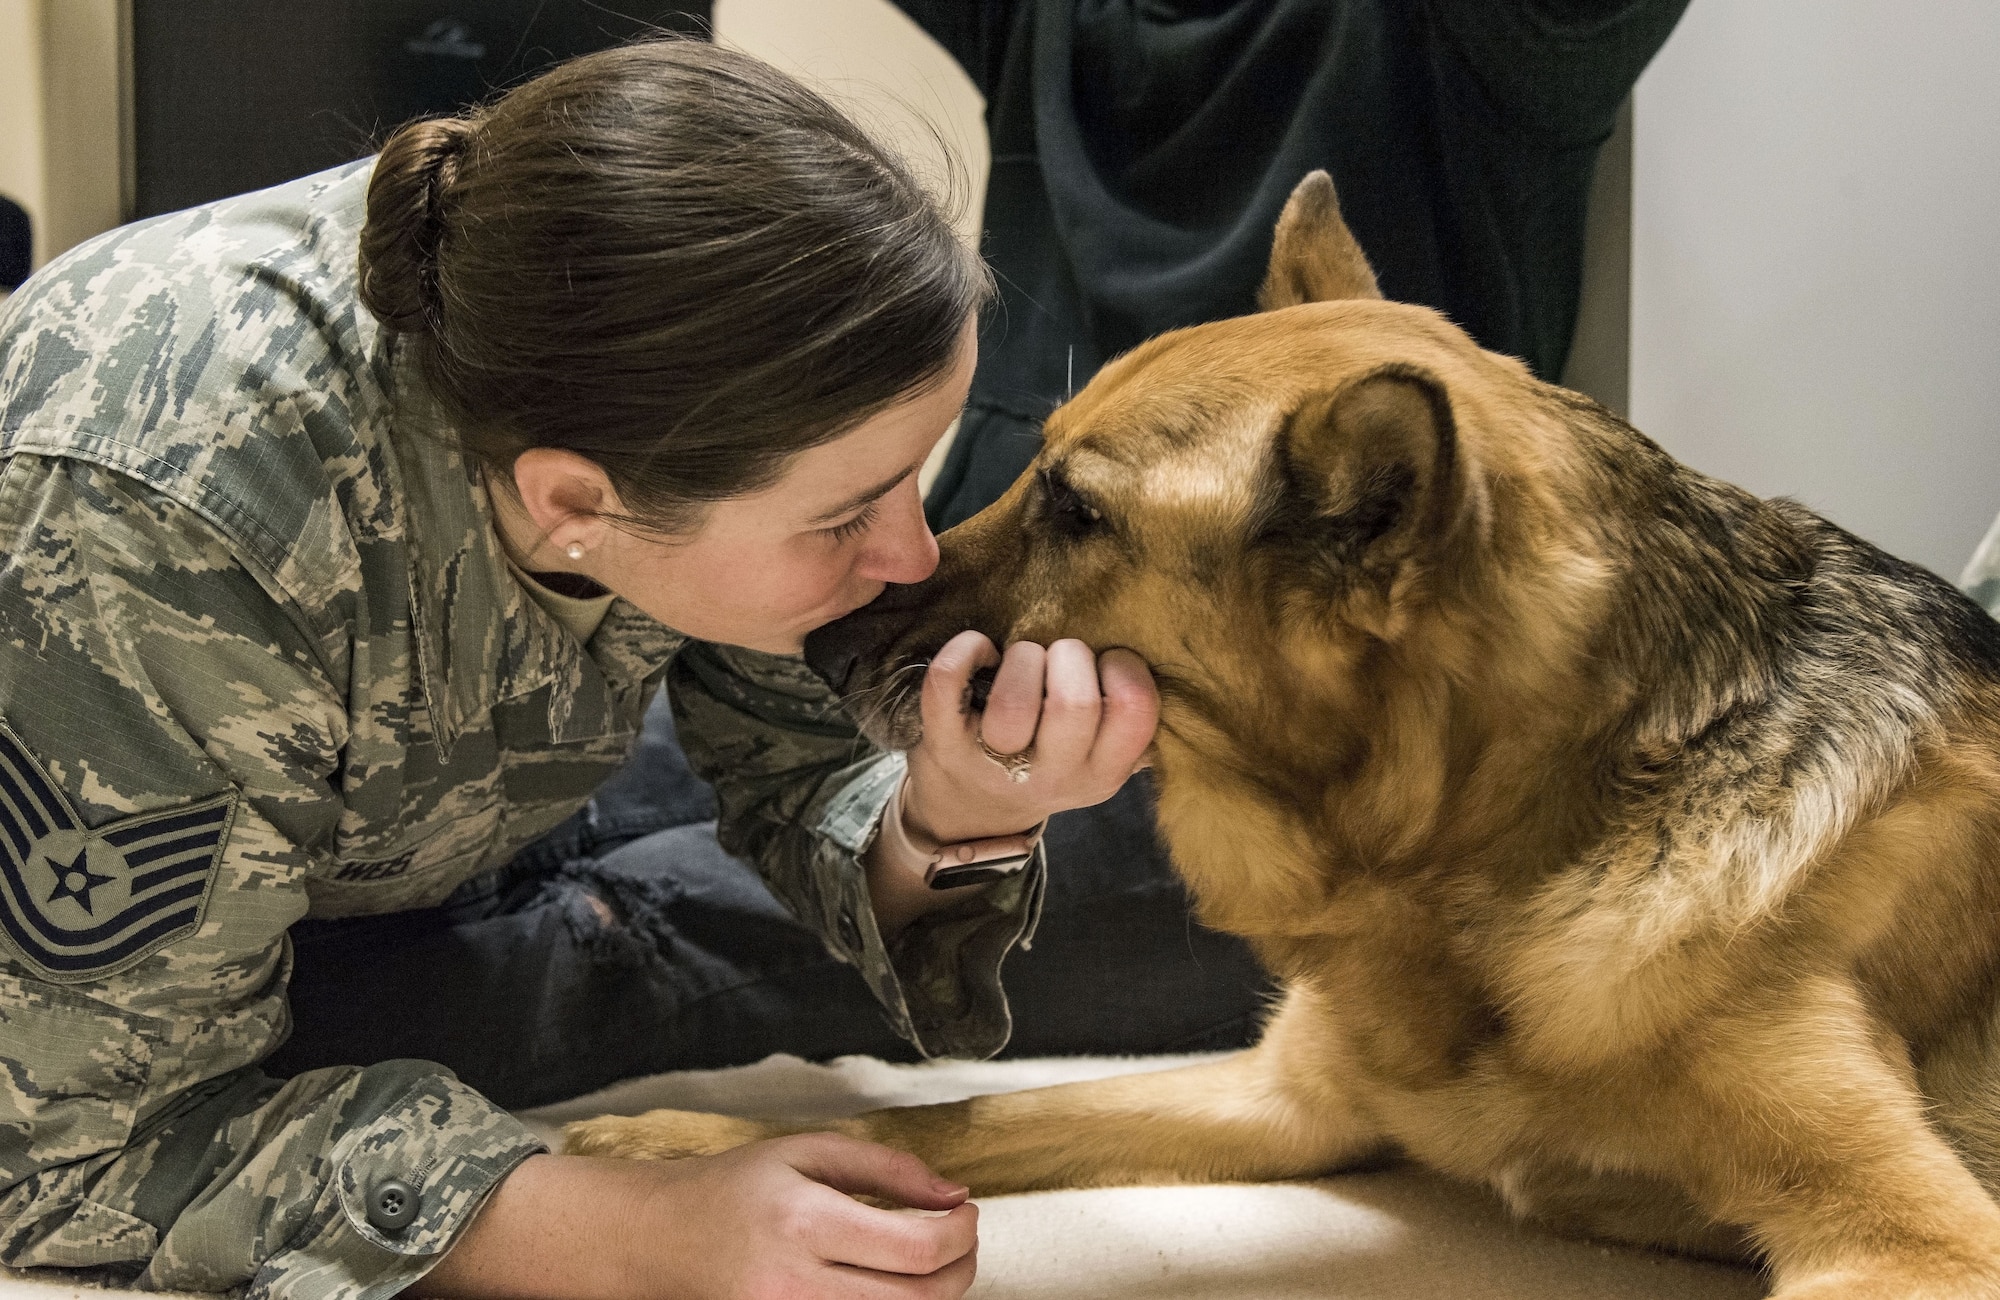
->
[[408, 1134, 978, 1300]]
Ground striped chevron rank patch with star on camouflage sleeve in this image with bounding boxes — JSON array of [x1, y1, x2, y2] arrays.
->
[[0, 722, 236, 984]]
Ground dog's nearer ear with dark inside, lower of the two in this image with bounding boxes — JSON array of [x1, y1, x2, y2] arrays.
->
[[1264, 362, 1464, 588]]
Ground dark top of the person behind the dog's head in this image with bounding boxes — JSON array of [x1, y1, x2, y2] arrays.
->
[[898, 0, 1686, 530]]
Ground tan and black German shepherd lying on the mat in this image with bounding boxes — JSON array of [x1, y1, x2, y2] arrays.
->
[[570, 172, 2000, 1300]]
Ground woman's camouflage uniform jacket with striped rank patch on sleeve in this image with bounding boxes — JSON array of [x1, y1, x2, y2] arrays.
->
[[0, 164, 1042, 1296]]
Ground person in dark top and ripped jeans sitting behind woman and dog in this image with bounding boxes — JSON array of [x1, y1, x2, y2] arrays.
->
[[270, 0, 1686, 1152]]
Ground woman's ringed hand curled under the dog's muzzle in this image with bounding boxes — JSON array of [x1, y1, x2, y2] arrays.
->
[[902, 632, 1160, 844]]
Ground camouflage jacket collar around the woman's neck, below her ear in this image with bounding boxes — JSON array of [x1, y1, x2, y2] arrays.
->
[[388, 348, 686, 754]]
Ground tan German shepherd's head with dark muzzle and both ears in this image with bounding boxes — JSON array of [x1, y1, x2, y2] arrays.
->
[[806, 172, 1600, 816]]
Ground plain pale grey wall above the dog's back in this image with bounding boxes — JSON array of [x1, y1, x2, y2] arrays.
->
[[1632, 0, 2000, 578]]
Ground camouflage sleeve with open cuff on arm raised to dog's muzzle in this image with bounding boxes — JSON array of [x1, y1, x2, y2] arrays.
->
[[668, 642, 1046, 1058]]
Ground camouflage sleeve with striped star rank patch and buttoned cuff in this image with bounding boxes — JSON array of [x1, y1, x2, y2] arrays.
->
[[0, 454, 542, 1298]]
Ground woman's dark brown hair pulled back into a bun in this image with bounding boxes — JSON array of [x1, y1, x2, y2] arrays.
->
[[360, 40, 990, 534]]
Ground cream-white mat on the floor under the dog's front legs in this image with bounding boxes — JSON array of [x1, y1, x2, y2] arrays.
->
[[524, 1056, 1766, 1300]]
